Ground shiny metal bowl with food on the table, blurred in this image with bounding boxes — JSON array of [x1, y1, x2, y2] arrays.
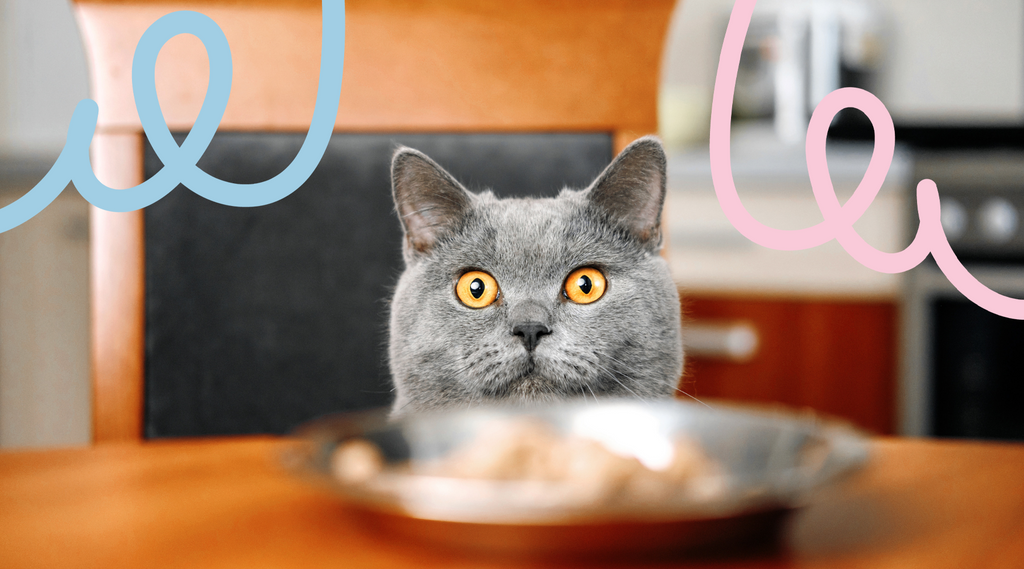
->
[[293, 400, 869, 560]]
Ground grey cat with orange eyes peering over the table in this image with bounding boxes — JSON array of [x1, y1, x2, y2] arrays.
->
[[389, 137, 683, 415]]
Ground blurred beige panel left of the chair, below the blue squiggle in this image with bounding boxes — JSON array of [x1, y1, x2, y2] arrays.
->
[[0, 190, 91, 447]]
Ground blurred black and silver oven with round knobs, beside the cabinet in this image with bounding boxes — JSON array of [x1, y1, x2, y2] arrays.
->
[[900, 150, 1024, 440]]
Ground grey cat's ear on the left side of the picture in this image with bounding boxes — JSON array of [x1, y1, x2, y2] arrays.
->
[[391, 147, 470, 253]]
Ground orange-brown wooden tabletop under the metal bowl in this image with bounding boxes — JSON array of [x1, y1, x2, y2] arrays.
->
[[0, 438, 1024, 569]]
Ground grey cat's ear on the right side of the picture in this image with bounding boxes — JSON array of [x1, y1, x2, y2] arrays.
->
[[588, 136, 666, 248]]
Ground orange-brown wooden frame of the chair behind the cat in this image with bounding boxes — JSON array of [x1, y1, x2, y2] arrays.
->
[[75, 0, 673, 442]]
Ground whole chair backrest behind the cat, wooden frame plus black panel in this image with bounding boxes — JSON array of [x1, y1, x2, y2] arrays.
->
[[76, 0, 673, 441]]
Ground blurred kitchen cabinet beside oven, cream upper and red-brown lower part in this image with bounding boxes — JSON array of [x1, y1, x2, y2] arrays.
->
[[665, 133, 916, 434]]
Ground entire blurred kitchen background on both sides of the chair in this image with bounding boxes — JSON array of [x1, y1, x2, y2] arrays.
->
[[0, 0, 1024, 447]]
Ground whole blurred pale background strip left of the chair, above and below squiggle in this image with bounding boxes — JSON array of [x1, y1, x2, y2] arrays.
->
[[0, 0, 91, 447]]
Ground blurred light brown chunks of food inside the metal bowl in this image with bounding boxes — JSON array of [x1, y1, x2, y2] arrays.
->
[[333, 418, 724, 506]]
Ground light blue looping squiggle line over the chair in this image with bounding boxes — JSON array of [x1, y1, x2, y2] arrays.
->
[[0, 0, 345, 232]]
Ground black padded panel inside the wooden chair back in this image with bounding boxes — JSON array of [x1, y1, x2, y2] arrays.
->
[[143, 133, 611, 438]]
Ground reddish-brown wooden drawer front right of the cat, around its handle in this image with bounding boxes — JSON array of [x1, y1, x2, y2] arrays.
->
[[680, 293, 897, 434]]
